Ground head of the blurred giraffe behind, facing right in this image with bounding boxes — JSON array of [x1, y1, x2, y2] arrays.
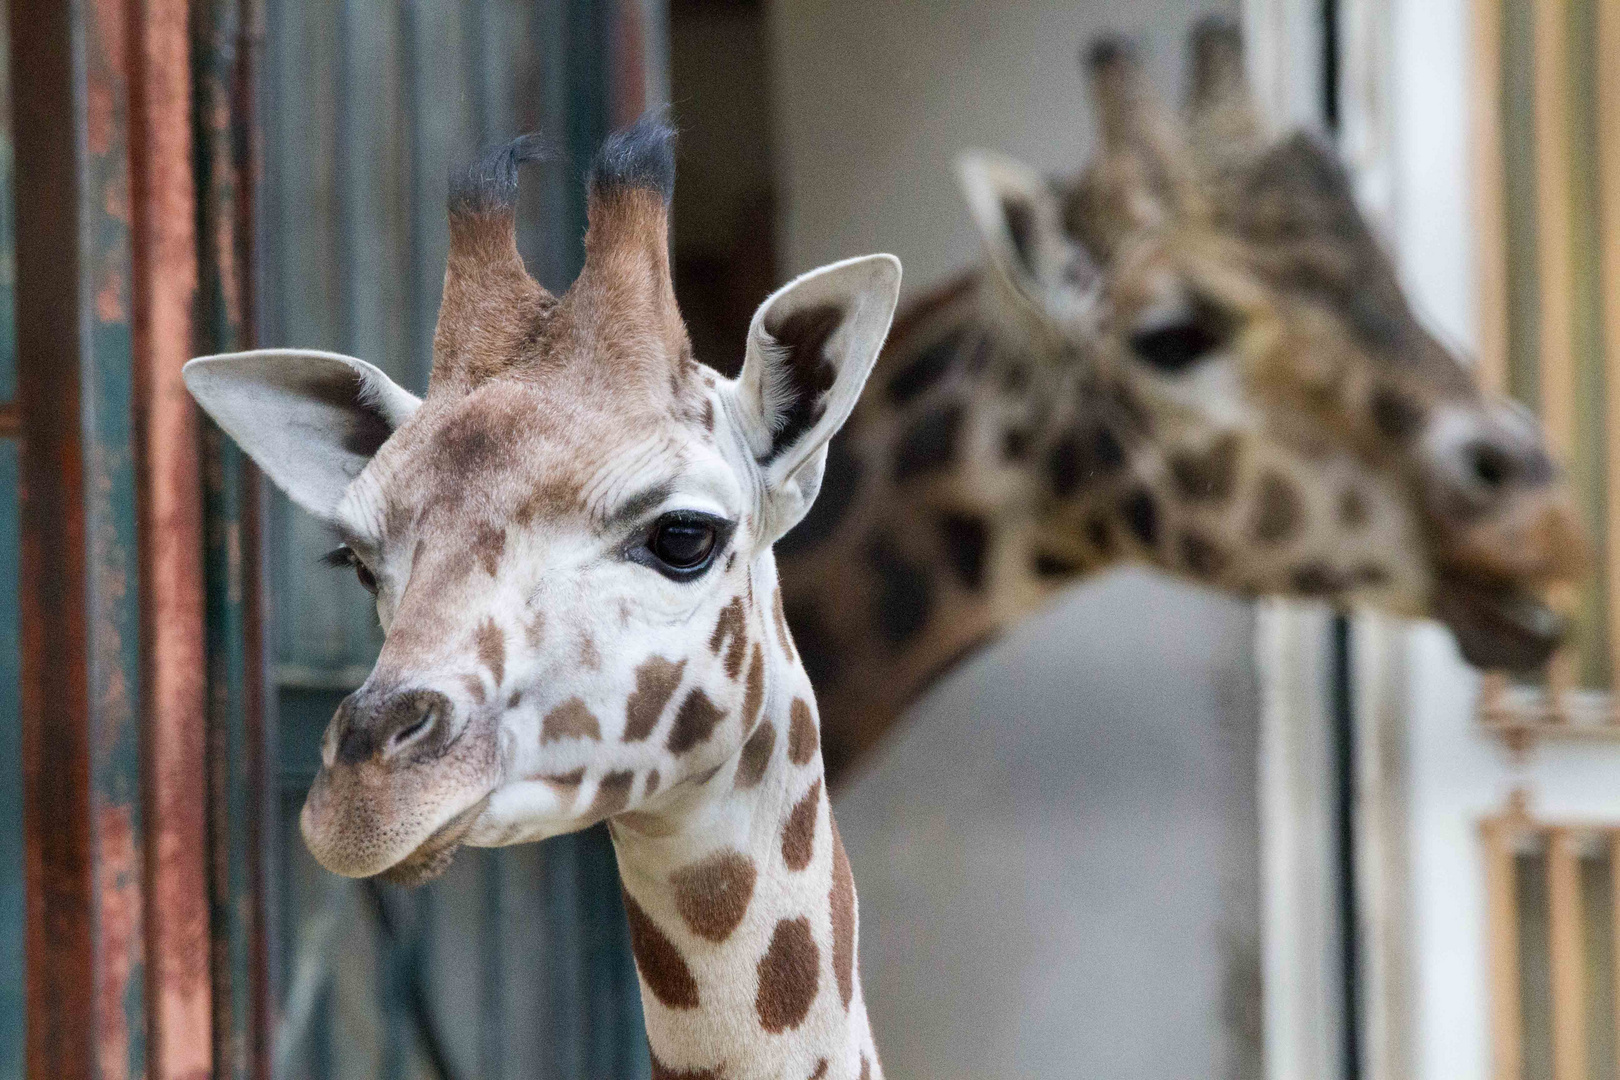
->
[[961, 19, 1586, 669]]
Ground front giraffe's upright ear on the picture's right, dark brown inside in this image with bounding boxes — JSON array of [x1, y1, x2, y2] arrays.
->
[[732, 254, 901, 542]]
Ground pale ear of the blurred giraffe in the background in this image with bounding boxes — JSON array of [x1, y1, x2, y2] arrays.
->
[[956, 151, 1100, 325]]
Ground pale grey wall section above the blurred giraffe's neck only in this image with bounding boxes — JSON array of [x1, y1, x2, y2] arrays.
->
[[770, 0, 1238, 293]]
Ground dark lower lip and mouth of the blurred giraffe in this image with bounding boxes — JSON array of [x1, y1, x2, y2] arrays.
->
[[1434, 575, 1567, 674]]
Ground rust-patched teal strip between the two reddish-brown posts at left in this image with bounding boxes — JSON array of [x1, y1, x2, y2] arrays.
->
[[78, 6, 146, 1077]]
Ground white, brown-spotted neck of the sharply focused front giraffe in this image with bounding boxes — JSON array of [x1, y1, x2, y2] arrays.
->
[[611, 554, 881, 1080]]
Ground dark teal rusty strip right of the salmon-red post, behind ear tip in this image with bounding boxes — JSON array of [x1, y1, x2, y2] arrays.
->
[[191, 0, 267, 1080]]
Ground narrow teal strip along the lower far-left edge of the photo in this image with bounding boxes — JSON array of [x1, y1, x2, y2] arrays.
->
[[0, 439, 24, 1080]]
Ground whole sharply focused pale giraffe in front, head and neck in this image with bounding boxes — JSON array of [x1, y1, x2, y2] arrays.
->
[[186, 118, 899, 1080]]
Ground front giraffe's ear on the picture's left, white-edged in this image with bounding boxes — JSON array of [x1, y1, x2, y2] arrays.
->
[[183, 348, 421, 521]]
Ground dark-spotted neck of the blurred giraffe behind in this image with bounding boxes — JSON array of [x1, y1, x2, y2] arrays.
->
[[778, 272, 1106, 782]]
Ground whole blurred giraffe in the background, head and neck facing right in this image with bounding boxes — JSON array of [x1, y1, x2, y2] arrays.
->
[[778, 19, 1583, 780]]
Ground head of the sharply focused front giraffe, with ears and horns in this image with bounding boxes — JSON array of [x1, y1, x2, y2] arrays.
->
[[186, 117, 899, 881]]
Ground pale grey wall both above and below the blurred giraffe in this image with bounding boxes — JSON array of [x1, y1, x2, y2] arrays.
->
[[771, 0, 1260, 1080]]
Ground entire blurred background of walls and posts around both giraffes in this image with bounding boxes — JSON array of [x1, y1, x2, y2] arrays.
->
[[0, 0, 1620, 1080]]
